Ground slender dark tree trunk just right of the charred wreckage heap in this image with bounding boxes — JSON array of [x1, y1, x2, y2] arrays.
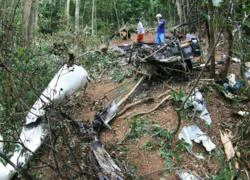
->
[[207, 0, 215, 78]]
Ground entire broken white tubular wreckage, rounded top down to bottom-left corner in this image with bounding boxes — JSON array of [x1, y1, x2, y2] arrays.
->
[[0, 65, 88, 180]]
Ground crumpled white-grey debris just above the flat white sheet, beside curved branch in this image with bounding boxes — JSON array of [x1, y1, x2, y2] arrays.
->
[[189, 89, 212, 125]]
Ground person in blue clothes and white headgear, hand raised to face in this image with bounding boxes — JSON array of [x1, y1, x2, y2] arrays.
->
[[155, 14, 165, 45]]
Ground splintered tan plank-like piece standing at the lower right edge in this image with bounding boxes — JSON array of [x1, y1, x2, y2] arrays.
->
[[220, 131, 235, 161]]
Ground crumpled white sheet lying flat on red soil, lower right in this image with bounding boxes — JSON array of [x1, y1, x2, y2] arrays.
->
[[178, 125, 216, 159]]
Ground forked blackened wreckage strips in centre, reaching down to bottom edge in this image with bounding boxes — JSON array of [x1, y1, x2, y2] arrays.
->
[[65, 77, 145, 180]]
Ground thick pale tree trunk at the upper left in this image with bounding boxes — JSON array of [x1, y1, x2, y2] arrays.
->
[[22, 0, 36, 47]]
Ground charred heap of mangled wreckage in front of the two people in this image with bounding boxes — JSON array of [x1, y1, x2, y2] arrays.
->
[[112, 34, 201, 77]]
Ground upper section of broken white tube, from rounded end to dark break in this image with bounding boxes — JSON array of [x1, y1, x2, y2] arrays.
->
[[25, 64, 88, 125]]
